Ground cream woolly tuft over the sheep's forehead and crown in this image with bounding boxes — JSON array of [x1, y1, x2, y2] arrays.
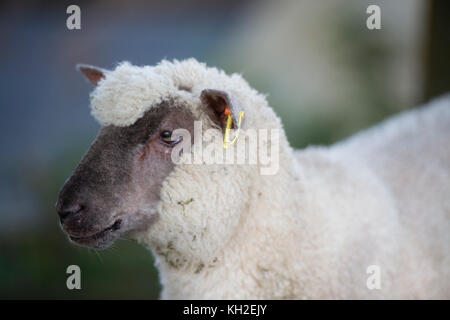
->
[[91, 58, 257, 127]]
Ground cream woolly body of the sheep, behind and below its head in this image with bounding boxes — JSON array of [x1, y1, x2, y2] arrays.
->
[[146, 98, 450, 299]]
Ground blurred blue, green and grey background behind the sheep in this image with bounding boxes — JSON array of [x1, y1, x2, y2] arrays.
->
[[0, 0, 450, 299]]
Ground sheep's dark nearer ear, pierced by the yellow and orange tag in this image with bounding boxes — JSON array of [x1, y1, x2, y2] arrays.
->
[[200, 89, 244, 129]]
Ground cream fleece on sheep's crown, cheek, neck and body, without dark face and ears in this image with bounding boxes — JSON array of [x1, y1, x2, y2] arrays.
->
[[89, 60, 450, 299]]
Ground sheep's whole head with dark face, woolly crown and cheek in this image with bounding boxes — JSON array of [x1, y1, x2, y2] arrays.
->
[[57, 61, 265, 258]]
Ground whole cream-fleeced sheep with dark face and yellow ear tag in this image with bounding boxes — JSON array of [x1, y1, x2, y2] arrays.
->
[[56, 59, 450, 299]]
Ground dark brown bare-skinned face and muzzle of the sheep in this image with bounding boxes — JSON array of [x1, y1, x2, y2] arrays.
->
[[56, 103, 194, 248]]
